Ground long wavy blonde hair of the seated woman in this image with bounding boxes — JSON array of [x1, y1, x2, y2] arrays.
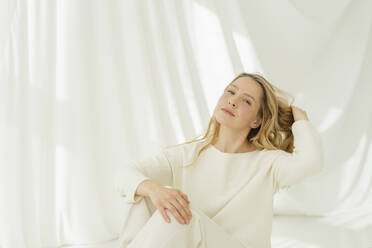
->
[[167, 72, 294, 167]]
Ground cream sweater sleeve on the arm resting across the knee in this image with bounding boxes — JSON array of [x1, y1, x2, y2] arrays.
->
[[114, 145, 180, 204]]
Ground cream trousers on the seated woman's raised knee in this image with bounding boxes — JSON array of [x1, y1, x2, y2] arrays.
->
[[119, 197, 247, 248]]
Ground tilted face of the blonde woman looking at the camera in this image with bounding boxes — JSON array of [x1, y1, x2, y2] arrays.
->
[[214, 77, 263, 129]]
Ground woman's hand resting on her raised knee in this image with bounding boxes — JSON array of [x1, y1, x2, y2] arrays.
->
[[148, 184, 192, 224]]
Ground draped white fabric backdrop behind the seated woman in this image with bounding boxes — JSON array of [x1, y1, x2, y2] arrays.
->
[[0, 0, 372, 248]]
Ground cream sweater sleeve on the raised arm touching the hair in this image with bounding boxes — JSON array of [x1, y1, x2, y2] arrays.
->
[[272, 120, 324, 193]]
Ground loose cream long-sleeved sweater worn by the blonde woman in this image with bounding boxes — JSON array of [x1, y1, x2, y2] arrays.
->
[[115, 120, 323, 248]]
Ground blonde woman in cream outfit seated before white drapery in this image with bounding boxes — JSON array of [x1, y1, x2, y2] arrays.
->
[[116, 73, 323, 248]]
